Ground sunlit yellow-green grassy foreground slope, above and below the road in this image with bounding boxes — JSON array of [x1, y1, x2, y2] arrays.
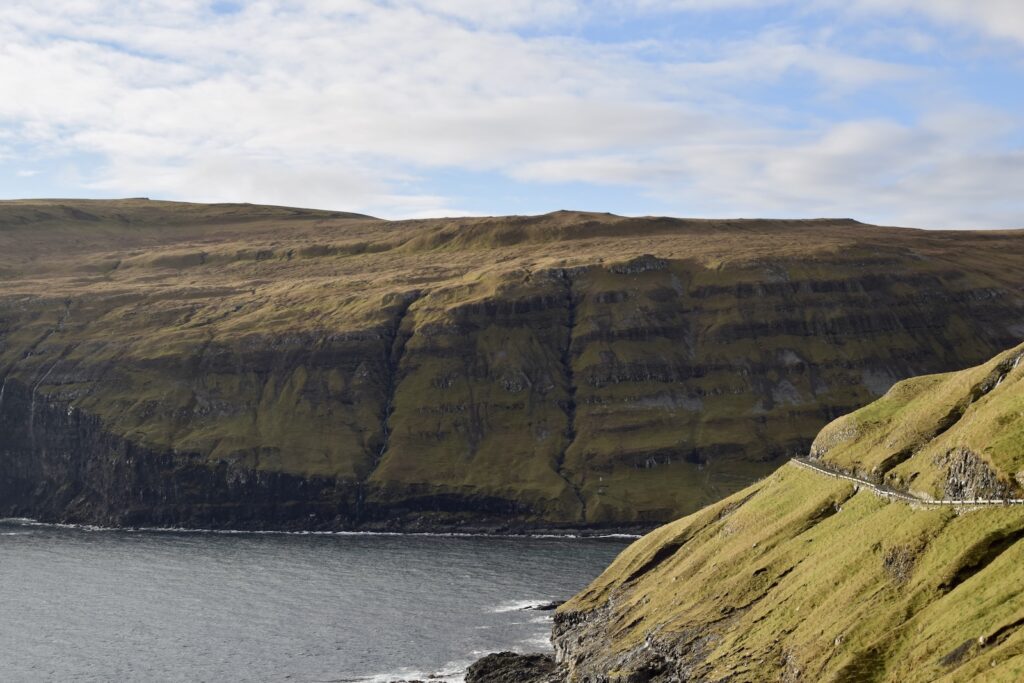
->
[[554, 345, 1024, 682]]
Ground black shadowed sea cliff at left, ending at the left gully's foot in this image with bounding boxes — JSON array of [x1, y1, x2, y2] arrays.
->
[[0, 381, 362, 529]]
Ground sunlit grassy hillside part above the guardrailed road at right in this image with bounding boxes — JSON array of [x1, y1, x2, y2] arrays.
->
[[812, 347, 1024, 498]]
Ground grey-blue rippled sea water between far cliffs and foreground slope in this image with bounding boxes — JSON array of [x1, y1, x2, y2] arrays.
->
[[0, 521, 625, 683]]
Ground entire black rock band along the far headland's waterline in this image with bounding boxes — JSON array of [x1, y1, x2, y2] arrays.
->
[[0, 381, 644, 535]]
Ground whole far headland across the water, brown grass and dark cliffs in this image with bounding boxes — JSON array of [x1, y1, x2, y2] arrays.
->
[[0, 201, 1024, 528]]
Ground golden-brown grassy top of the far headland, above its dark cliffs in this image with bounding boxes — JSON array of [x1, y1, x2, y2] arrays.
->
[[0, 200, 1024, 328]]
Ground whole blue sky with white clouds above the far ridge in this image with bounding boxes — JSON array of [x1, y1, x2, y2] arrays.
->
[[0, 0, 1024, 228]]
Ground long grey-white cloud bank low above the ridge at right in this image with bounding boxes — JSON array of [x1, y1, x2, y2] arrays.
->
[[515, 108, 1024, 228]]
